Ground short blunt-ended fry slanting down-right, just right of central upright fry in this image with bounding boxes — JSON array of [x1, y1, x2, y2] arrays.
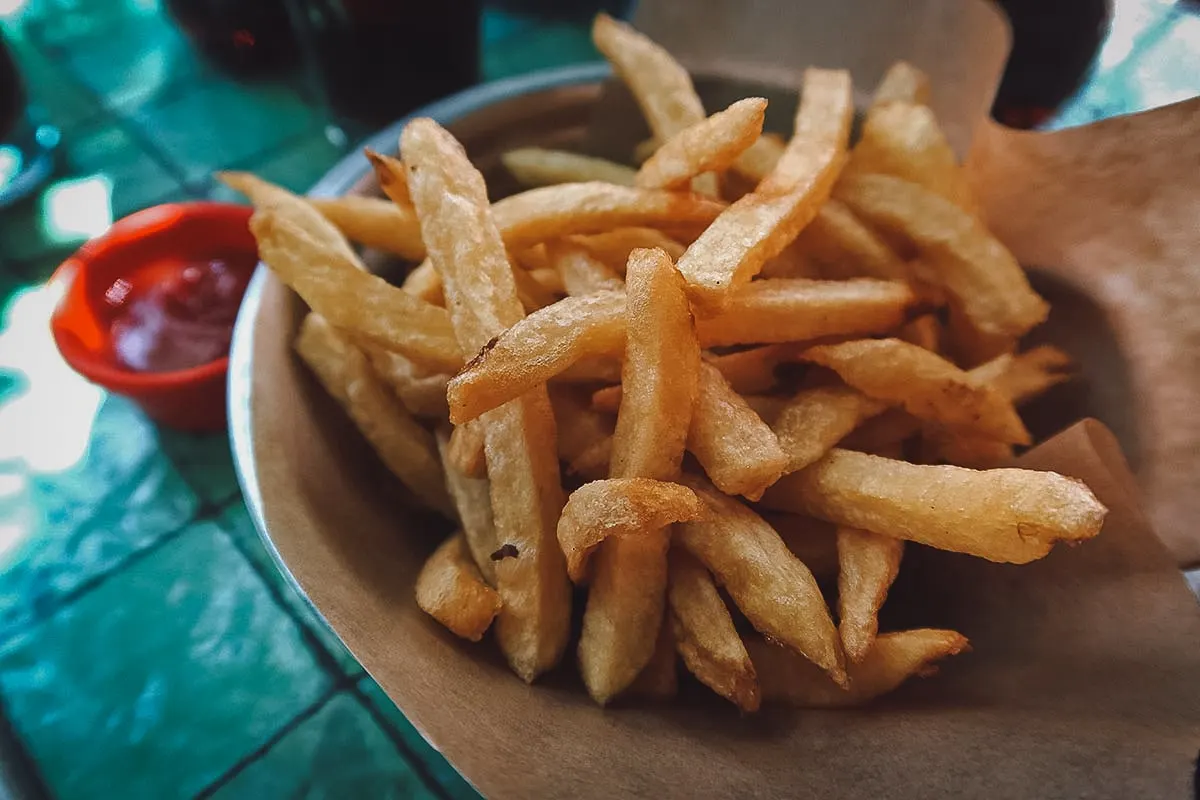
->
[[688, 363, 787, 500]]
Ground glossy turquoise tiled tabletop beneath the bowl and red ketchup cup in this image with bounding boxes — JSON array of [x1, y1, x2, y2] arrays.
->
[[0, 0, 1200, 799]]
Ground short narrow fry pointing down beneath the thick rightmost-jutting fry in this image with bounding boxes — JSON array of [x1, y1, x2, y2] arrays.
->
[[838, 527, 904, 663]]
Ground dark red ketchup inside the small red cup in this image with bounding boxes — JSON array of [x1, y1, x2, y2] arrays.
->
[[104, 259, 251, 372]]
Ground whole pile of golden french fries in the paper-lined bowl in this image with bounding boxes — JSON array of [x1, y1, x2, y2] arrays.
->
[[222, 16, 1106, 711]]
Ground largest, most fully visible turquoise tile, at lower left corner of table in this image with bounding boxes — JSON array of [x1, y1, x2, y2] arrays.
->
[[0, 524, 330, 800]]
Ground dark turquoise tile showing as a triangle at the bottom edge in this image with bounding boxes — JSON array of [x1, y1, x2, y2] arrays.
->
[[212, 692, 437, 800]]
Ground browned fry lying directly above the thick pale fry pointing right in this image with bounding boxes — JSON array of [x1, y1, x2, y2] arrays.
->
[[800, 339, 1030, 444]]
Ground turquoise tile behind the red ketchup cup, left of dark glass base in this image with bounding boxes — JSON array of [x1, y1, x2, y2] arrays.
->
[[133, 80, 323, 181]]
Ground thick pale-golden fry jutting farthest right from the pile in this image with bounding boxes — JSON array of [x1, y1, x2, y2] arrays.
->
[[763, 449, 1108, 564]]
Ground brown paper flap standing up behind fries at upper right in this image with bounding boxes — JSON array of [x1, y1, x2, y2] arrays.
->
[[635, 0, 1200, 566]]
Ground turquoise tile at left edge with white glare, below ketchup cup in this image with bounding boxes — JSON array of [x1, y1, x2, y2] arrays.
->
[[0, 398, 198, 642]]
